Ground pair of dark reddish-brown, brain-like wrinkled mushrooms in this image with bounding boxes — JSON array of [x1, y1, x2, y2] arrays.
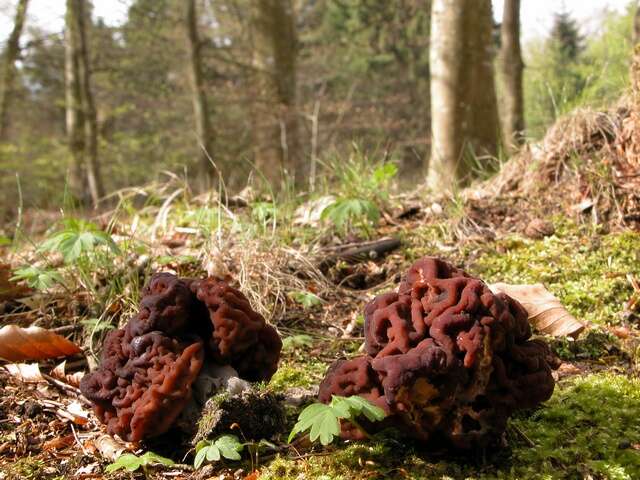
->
[[81, 257, 557, 449]]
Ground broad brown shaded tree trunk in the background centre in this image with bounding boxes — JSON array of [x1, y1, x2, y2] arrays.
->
[[252, 0, 306, 188]]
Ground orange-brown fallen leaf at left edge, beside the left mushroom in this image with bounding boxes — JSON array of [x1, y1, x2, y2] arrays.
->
[[0, 325, 82, 362]]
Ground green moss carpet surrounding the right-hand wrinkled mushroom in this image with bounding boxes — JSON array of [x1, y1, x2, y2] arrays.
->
[[260, 218, 640, 480]]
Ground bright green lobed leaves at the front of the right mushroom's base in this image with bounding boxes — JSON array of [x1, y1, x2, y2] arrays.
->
[[288, 395, 385, 445]]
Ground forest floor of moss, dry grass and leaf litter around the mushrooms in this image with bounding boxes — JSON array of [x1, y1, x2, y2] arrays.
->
[[0, 98, 640, 480]]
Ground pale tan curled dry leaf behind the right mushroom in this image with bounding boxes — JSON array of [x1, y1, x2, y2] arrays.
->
[[489, 283, 586, 338]]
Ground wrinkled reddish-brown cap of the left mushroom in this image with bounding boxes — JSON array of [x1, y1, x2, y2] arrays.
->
[[80, 273, 282, 441]]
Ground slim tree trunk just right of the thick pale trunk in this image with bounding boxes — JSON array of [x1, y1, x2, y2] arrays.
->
[[500, 0, 524, 153]]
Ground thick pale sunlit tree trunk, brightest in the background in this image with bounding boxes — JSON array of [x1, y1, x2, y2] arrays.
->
[[428, 0, 500, 190]]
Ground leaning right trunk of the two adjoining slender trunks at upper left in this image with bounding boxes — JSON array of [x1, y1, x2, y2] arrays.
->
[[75, 0, 104, 207]]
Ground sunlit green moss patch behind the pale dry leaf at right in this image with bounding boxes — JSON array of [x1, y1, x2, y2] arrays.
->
[[470, 222, 640, 324]]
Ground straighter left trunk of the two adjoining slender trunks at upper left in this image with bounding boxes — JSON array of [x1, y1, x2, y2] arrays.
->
[[64, 0, 86, 202]]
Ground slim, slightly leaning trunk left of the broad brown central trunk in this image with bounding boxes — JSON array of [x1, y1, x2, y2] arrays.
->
[[184, 0, 215, 190]]
